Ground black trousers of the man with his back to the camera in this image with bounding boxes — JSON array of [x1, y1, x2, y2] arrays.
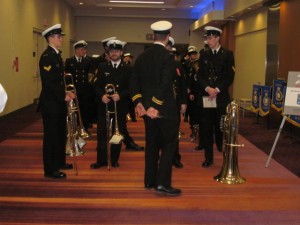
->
[[144, 116, 178, 187]]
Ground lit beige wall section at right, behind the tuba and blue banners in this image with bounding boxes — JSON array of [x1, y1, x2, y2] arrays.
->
[[233, 7, 267, 99]]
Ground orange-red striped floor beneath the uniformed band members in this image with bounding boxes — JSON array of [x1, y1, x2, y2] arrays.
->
[[0, 115, 300, 225]]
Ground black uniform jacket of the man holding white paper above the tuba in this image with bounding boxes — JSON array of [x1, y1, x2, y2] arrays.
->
[[196, 47, 235, 107]]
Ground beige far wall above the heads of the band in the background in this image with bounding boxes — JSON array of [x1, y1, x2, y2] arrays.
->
[[76, 17, 194, 44]]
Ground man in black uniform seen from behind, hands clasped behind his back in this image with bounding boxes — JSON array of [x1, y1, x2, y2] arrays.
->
[[130, 21, 181, 196]]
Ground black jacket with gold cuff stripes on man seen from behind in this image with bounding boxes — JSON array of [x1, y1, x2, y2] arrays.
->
[[130, 44, 178, 120]]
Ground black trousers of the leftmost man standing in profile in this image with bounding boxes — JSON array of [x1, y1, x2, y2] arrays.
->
[[42, 113, 67, 173]]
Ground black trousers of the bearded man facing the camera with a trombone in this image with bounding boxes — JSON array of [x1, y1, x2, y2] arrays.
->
[[97, 113, 126, 164]]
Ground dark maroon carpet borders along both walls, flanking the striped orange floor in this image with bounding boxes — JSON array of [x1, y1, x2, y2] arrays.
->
[[0, 105, 300, 177]]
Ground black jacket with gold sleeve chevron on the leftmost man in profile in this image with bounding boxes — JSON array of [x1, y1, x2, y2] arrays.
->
[[39, 46, 67, 113]]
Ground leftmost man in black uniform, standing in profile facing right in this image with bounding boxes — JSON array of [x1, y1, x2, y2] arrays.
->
[[39, 24, 75, 178]]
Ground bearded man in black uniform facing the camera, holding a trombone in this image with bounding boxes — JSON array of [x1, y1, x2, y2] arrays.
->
[[91, 40, 132, 169]]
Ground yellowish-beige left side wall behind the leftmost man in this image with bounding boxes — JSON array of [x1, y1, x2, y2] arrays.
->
[[0, 0, 75, 116]]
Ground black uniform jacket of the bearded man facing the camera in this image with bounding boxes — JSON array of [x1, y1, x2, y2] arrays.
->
[[94, 62, 132, 114]]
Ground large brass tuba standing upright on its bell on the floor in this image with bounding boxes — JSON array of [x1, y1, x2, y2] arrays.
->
[[214, 100, 246, 184]]
